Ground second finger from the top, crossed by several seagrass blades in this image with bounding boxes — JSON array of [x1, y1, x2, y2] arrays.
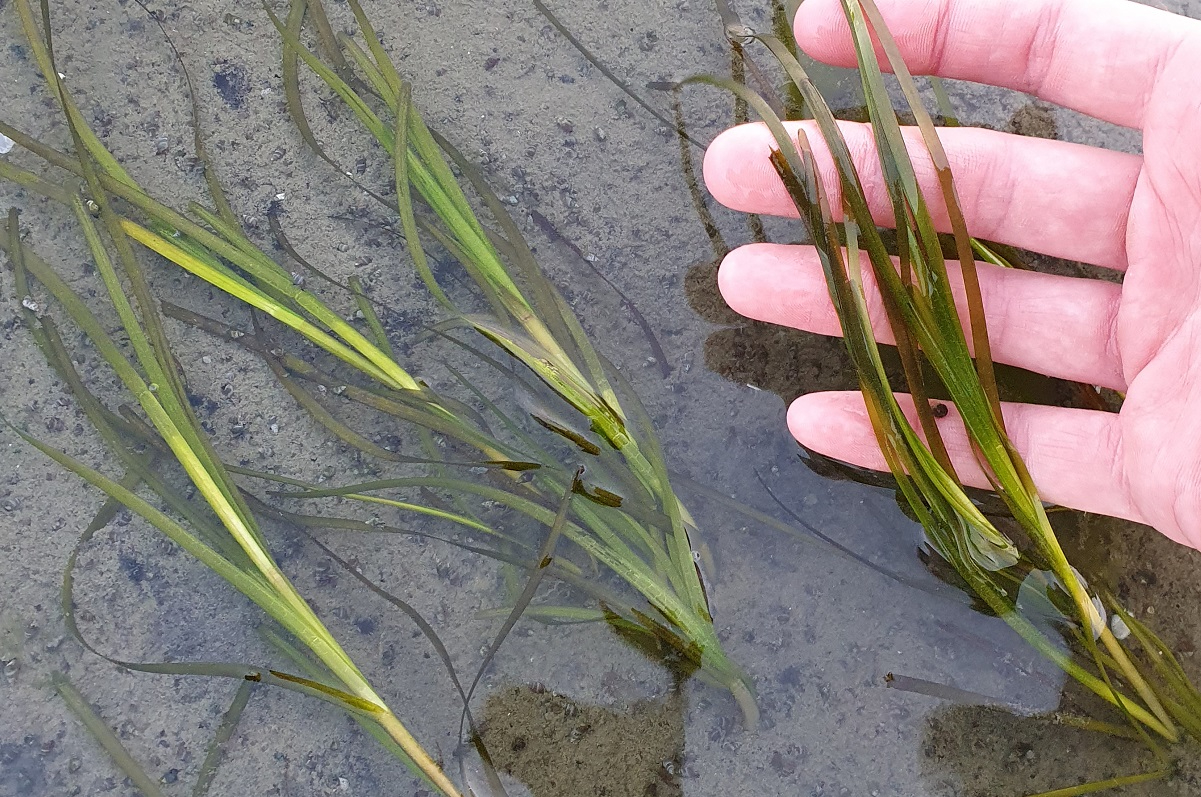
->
[[704, 120, 1142, 269]]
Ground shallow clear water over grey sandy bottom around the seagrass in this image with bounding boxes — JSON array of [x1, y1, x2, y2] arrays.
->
[[0, 0, 1201, 797]]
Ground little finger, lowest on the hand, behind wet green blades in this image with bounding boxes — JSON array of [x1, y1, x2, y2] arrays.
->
[[788, 392, 1147, 522]]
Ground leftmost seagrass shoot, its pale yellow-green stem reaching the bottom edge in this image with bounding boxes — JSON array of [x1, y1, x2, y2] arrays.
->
[[0, 0, 459, 796]]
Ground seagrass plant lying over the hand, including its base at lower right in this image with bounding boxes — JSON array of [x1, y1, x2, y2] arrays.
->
[[697, 0, 1201, 793]]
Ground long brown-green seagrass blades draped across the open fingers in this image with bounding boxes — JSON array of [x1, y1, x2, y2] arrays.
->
[[707, 0, 1191, 742]]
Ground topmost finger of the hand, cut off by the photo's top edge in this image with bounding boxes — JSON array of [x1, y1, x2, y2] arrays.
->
[[795, 0, 1201, 127]]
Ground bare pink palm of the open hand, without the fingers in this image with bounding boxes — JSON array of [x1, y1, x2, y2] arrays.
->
[[1115, 46, 1201, 547]]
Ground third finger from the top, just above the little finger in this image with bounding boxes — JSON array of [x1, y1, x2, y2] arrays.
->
[[717, 244, 1127, 390]]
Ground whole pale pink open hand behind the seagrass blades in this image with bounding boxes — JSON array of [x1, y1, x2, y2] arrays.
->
[[705, 0, 1201, 549]]
